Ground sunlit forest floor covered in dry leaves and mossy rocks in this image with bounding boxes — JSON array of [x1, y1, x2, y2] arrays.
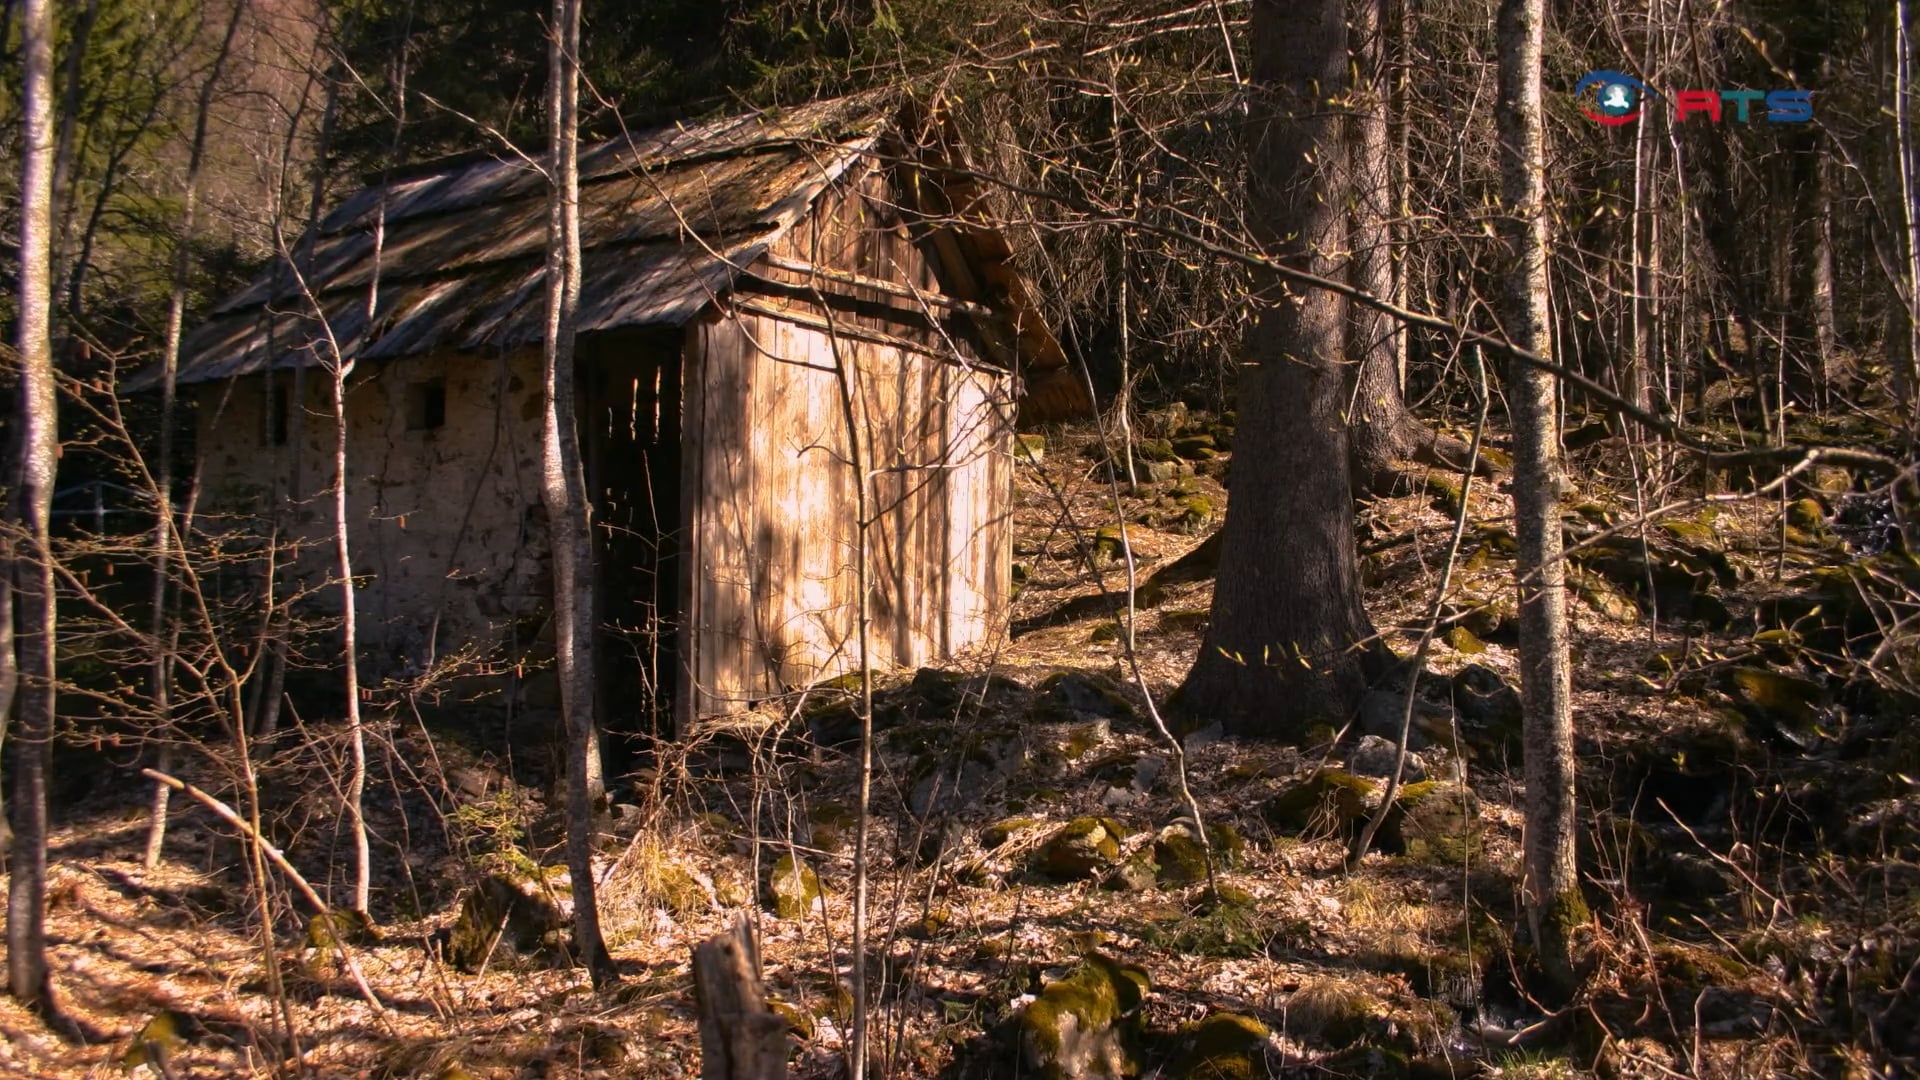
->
[[0, 407, 1920, 1080]]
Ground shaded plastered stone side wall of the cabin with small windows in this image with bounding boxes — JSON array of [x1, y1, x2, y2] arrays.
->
[[196, 350, 551, 676]]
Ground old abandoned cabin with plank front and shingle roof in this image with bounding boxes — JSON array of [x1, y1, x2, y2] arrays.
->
[[142, 100, 1087, 730]]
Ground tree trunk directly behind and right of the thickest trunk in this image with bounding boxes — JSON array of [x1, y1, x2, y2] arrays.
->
[[1346, 0, 1467, 486]]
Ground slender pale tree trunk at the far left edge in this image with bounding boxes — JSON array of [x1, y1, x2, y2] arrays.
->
[[6, 0, 60, 1011]]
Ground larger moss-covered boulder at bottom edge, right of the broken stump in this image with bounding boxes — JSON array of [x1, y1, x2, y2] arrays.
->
[[1016, 953, 1152, 1080]]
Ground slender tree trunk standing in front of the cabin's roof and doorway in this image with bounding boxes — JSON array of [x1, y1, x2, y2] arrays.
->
[[541, 0, 616, 986]]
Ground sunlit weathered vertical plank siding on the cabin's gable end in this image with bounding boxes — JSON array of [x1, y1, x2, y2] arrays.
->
[[680, 173, 1012, 719]]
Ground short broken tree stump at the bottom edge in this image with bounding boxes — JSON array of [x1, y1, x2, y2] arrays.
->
[[693, 915, 787, 1080]]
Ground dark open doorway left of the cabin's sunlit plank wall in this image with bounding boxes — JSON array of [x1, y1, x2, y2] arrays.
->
[[580, 331, 682, 776]]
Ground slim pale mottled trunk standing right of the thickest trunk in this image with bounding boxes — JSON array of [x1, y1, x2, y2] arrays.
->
[[1494, 0, 1588, 990]]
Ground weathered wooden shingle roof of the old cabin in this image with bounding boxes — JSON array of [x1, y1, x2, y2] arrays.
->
[[127, 98, 1066, 403]]
